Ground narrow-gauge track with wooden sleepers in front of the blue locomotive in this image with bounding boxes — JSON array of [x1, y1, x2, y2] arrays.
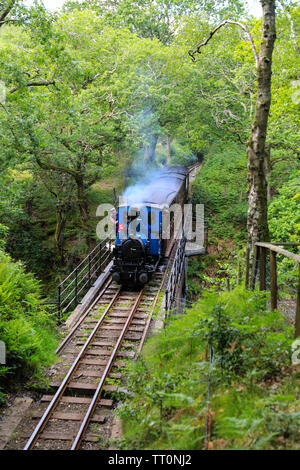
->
[[24, 257, 171, 450]]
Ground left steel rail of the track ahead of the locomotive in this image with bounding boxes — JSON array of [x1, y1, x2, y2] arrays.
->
[[24, 287, 121, 450]]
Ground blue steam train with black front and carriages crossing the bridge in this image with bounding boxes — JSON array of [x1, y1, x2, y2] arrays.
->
[[110, 166, 189, 285]]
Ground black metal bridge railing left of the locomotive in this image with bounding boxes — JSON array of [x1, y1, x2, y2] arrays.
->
[[57, 237, 112, 317]]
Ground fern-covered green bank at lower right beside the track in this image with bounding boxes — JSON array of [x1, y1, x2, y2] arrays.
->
[[119, 288, 300, 449]]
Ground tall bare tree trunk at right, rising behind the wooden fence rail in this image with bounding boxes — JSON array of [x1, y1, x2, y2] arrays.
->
[[246, 0, 276, 272]]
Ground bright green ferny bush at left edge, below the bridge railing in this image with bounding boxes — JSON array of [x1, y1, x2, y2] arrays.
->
[[0, 251, 57, 398]]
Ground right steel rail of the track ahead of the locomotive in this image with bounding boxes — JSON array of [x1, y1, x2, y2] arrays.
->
[[70, 288, 145, 450]]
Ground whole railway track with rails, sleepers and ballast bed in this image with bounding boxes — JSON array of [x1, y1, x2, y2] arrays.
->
[[7, 163, 201, 450]]
